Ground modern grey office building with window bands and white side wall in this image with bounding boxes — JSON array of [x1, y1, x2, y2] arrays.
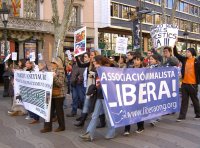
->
[[95, 0, 200, 53]]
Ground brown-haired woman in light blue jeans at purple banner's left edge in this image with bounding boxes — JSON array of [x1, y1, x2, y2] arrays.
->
[[80, 55, 115, 141]]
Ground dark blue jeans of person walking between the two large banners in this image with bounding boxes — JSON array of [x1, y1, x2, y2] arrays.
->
[[72, 84, 86, 114]]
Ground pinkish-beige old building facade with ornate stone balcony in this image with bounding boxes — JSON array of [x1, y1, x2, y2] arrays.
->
[[0, 0, 94, 82]]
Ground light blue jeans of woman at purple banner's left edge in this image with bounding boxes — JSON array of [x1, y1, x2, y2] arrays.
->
[[86, 99, 115, 139]]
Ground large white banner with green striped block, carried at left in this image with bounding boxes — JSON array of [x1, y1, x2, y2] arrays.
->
[[14, 71, 53, 122]]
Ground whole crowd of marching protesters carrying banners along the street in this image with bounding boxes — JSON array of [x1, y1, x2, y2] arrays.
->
[[4, 46, 200, 141]]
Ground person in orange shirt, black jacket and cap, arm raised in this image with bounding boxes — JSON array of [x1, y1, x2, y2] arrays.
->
[[174, 46, 200, 122]]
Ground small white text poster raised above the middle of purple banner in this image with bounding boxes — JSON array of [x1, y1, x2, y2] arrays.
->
[[115, 37, 128, 54]]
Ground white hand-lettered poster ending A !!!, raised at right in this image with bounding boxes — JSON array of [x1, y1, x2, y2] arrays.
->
[[151, 24, 178, 49]]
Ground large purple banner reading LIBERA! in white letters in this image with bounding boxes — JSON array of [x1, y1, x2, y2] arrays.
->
[[97, 67, 180, 127]]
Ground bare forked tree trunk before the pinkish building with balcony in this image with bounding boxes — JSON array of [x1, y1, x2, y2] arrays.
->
[[51, 0, 74, 58]]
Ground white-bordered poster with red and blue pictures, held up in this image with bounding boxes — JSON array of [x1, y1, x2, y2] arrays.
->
[[74, 27, 86, 56]]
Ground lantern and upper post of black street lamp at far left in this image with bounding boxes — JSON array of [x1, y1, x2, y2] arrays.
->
[[0, 2, 10, 57]]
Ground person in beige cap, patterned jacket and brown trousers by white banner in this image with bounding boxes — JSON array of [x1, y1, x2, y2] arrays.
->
[[40, 57, 65, 133]]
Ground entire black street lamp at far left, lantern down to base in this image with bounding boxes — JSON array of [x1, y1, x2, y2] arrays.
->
[[0, 2, 10, 97]]
